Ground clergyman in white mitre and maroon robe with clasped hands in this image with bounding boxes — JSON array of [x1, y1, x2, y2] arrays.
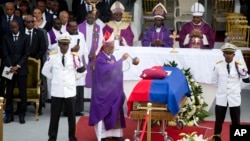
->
[[179, 2, 215, 48]]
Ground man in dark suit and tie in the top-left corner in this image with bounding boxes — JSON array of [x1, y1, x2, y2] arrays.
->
[[1, 2, 24, 34]]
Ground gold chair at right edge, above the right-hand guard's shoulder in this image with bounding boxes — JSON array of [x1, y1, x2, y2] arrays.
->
[[228, 25, 250, 47]]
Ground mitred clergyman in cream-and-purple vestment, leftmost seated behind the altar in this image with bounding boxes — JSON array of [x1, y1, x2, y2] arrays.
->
[[103, 1, 134, 46]]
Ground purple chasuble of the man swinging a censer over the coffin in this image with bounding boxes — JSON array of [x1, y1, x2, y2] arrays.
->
[[89, 51, 125, 130]]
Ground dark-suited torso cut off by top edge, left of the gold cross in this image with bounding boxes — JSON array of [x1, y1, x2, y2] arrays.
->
[[72, 0, 93, 24]]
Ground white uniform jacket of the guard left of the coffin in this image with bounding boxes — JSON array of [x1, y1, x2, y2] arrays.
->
[[42, 51, 81, 98]]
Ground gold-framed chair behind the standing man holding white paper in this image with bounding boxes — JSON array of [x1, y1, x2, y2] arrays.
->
[[13, 57, 41, 120]]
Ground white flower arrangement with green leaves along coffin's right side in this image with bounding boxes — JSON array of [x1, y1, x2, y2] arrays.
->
[[164, 61, 210, 126]]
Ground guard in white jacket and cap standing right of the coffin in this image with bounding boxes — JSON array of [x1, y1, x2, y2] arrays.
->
[[212, 43, 249, 141]]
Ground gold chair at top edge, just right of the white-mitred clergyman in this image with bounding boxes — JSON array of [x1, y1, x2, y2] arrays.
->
[[212, 0, 234, 33]]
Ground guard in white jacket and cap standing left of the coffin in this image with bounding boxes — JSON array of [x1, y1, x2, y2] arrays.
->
[[42, 34, 84, 141]]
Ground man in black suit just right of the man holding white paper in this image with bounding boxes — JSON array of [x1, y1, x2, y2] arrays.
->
[[24, 15, 47, 115]]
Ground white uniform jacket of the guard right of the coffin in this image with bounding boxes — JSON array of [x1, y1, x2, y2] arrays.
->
[[212, 61, 248, 107]]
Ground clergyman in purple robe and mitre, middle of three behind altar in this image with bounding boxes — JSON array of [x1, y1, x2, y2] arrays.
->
[[142, 3, 173, 47]]
